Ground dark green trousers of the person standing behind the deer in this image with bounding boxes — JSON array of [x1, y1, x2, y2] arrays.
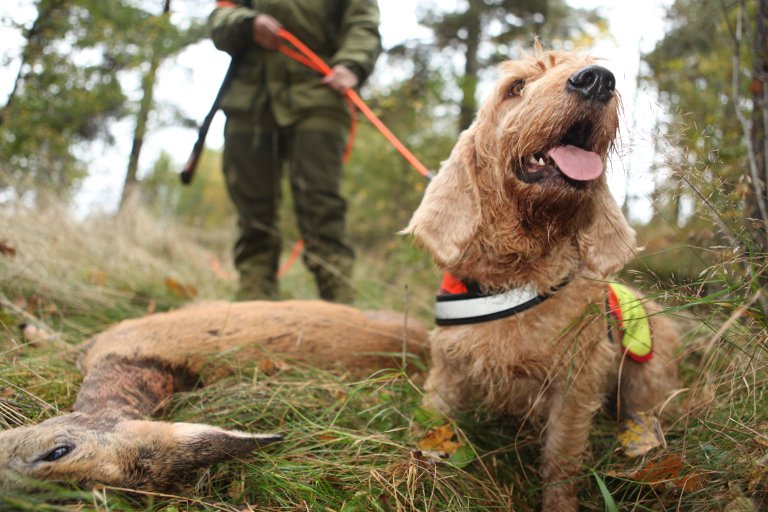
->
[[224, 115, 354, 302]]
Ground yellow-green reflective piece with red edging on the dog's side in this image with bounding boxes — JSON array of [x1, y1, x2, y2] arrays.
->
[[608, 283, 653, 363]]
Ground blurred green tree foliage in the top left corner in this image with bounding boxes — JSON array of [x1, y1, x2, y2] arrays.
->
[[0, 0, 203, 200]]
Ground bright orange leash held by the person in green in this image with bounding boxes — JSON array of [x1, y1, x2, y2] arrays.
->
[[277, 28, 433, 277]]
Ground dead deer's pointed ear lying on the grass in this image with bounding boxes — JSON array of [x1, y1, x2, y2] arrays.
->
[[172, 423, 283, 467]]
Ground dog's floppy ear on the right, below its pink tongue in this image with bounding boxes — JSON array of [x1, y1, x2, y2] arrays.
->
[[576, 183, 637, 277]]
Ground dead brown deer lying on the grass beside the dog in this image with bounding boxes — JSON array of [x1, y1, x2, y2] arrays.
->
[[0, 301, 427, 490]]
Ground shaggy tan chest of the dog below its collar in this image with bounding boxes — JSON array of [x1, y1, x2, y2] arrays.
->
[[432, 290, 605, 414]]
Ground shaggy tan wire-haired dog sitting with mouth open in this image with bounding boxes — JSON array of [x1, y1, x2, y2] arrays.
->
[[405, 45, 678, 511]]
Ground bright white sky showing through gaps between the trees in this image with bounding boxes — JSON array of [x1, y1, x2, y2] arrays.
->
[[0, 0, 670, 220]]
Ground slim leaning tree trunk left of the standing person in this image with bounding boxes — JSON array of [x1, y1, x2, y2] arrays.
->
[[118, 0, 171, 214]]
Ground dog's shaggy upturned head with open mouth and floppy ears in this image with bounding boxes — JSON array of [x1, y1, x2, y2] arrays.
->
[[405, 48, 635, 286]]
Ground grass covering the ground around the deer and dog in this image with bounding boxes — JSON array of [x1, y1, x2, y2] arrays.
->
[[0, 199, 768, 511]]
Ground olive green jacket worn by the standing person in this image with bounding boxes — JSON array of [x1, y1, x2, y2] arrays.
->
[[209, 0, 381, 126]]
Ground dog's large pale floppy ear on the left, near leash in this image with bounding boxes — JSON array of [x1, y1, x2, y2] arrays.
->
[[401, 131, 480, 266]]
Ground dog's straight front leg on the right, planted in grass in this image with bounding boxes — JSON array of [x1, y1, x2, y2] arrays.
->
[[541, 379, 601, 512]]
